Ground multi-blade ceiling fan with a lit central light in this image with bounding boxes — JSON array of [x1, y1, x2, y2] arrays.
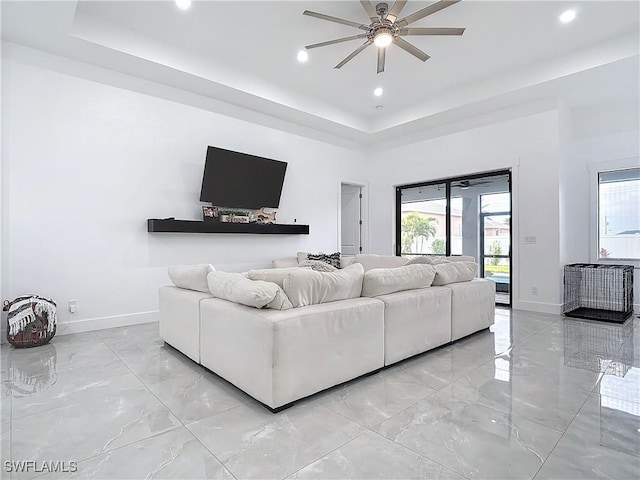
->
[[303, 0, 465, 73]]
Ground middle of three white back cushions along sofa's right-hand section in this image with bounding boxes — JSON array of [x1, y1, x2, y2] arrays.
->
[[362, 265, 436, 297]]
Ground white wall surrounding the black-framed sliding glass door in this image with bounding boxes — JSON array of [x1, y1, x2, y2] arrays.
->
[[370, 110, 560, 312]]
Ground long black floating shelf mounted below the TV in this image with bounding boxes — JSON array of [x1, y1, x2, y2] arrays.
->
[[147, 218, 309, 235]]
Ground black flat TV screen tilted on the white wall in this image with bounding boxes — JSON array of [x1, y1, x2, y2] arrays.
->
[[200, 147, 287, 209]]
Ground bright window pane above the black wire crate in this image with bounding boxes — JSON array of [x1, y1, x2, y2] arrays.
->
[[597, 168, 640, 260]]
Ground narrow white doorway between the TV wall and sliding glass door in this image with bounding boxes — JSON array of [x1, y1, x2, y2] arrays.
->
[[340, 183, 362, 256]]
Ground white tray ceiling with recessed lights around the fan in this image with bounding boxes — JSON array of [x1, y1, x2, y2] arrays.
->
[[2, 0, 640, 144]]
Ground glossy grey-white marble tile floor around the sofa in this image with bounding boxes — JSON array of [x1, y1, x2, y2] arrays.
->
[[0, 308, 640, 480]]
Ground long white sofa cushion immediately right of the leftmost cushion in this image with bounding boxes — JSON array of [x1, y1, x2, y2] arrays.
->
[[207, 271, 279, 308]]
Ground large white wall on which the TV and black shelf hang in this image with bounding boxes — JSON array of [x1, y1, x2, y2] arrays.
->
[[2, 45, 364, 332]]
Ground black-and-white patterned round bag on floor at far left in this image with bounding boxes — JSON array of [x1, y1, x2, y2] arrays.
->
[[2, 295, 57, 348]]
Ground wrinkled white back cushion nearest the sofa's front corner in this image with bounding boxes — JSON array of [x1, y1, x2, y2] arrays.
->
[[283, 264, 364, 307]]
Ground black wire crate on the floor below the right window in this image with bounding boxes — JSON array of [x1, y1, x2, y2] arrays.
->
[[562, 263, 633, 323]]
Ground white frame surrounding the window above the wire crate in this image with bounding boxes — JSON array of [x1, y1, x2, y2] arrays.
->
[[589, 157, 640, 268]]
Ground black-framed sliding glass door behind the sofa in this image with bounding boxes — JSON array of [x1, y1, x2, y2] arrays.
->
[[396, 171, 511, 304]]
